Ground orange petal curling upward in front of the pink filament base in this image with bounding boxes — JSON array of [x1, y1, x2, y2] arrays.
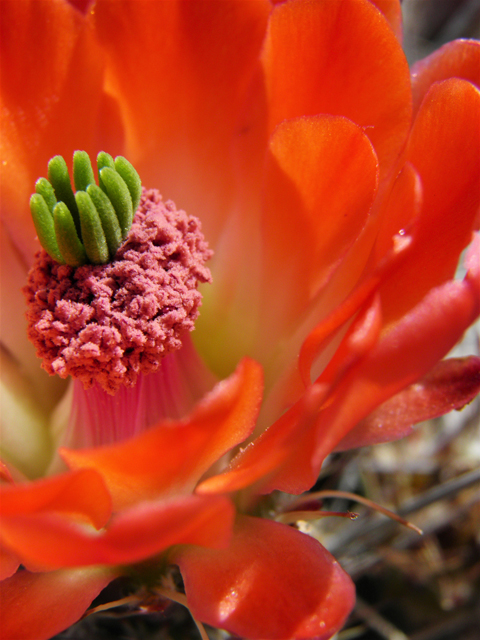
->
[[62, 358, 263, 510]]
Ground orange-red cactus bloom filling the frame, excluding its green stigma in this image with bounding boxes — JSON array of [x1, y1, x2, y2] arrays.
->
[[0, 0, 480, 640]]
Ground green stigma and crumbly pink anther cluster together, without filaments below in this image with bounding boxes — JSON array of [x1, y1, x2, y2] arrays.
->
[[24, 151, 212, 395]]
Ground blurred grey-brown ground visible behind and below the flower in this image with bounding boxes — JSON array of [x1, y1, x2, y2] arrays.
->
[[56, 0, 480, 640]]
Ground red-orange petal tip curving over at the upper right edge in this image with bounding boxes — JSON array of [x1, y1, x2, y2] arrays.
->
[[412, 40, 480, 112]]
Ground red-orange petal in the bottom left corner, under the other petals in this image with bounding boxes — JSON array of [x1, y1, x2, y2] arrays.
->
[[0, 568, 116, 640]]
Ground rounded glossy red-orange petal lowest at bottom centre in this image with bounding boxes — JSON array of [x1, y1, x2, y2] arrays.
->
[[173, 517, 355, 640]]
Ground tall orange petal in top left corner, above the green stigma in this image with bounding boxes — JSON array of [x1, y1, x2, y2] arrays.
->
[[1, 0, 117, 263]]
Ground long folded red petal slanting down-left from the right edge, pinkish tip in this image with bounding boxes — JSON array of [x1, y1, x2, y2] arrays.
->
[[308, 258, 480, 472]]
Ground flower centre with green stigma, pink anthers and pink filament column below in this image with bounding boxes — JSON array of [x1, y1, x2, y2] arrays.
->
[[24, 152, 212, 444]]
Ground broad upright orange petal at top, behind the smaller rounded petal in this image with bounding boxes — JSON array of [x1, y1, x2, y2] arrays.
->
[[262, 0, 411, 175]]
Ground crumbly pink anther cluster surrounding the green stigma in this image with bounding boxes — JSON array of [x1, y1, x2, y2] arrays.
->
[[24, 189, 212, 394]]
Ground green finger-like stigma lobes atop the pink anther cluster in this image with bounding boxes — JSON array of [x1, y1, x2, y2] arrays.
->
[[30, 151, 142, 267]]
